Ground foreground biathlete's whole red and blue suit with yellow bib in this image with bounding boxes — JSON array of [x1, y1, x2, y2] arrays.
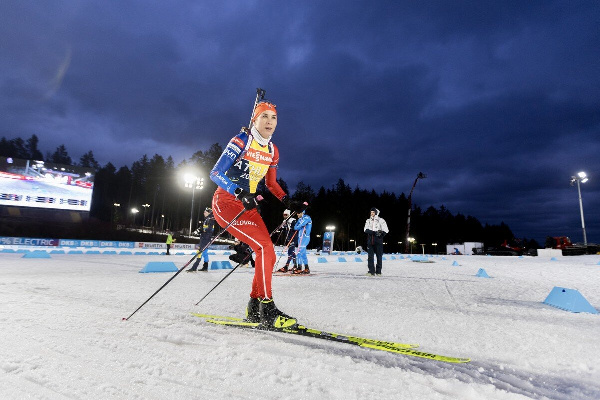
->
[[210, 131, 286, 299]]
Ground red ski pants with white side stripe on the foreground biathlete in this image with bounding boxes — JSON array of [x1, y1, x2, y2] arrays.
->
[[212, 188, 276, 299]]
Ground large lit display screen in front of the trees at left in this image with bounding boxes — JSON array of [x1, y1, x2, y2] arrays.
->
[[0, 157, 94, 211]]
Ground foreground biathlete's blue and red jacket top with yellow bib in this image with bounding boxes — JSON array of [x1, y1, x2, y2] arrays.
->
[[210, 131, 286, 200]]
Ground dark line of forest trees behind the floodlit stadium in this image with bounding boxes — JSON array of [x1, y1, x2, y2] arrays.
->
[[0, 135, 538, 253]]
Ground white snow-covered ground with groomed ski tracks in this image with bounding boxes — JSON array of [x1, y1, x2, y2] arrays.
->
[[0, 254, 600, 400]]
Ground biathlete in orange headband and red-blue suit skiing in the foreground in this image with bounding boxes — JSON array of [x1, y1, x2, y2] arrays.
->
[[210, 100, 302, 328]]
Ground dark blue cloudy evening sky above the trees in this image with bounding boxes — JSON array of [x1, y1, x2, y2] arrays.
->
[[0, 0, 600, 242]]
